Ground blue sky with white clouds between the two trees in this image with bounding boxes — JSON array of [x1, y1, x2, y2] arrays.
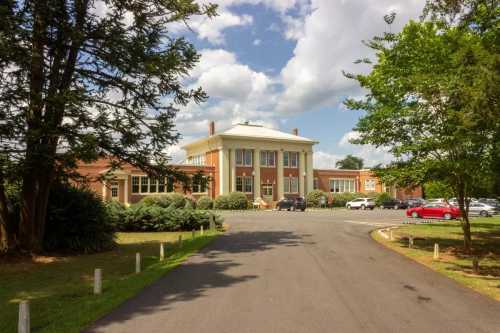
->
[[156, 0, 425, 168]]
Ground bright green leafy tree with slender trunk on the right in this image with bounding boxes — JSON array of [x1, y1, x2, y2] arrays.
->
[[346, 0, 500, 253]]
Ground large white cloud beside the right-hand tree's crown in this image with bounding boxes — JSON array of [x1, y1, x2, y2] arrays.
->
[[277, 0, 423, 113]]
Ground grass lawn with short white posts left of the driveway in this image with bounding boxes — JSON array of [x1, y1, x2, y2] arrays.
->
[[0, 232, 216, 333]]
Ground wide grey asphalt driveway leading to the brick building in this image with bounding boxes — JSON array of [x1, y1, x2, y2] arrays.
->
[[88, 210, 500, 333]]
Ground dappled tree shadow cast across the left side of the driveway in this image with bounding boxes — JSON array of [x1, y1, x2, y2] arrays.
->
[[84, 231, 310, 333]]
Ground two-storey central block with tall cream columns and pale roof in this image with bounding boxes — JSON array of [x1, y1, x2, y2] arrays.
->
[[183, 123, 317, 201]]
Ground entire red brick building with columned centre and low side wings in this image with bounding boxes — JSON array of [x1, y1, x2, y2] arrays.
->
[[79, 122, 422, 204]]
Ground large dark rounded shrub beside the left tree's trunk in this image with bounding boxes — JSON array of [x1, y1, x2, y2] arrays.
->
[[43, 185, 116, 253]]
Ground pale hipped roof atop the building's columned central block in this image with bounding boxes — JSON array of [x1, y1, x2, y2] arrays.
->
[[184, 123, 318, 148]]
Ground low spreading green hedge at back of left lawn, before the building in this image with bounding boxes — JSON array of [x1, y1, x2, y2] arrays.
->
[[119, 205, 222, 231]]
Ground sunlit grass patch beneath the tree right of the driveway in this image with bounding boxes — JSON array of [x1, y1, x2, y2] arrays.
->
[[372, 216, 500, 301]]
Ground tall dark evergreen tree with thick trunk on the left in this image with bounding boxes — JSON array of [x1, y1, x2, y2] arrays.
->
[[0, 0, 216, 251]]
